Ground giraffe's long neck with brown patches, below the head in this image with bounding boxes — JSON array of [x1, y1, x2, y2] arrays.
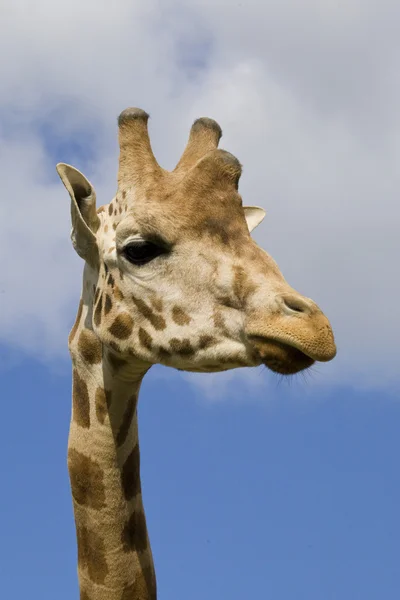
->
[[68, 303, 156, 600]]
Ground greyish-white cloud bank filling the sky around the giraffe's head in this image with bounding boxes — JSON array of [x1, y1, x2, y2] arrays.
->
[[0, 0, 400, 386]]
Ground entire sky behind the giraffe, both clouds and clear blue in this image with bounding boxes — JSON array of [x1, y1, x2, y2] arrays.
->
[[0, 0, 400, 600]]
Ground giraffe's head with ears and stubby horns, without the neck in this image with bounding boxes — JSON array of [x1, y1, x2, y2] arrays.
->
[[57, 108, 336, 374]]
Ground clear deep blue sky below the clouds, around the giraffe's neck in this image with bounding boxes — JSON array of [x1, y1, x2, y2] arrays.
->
[[0, 346, 400, 600]]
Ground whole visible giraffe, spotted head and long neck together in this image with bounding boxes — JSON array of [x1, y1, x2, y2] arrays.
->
[[57, 108, 336, 600]]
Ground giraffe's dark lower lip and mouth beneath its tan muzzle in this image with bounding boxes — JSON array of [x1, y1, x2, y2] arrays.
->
[[251, 336, 315, 375]]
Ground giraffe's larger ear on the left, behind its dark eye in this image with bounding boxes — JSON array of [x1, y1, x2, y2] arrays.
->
[[56, 163, 100, 264]]
